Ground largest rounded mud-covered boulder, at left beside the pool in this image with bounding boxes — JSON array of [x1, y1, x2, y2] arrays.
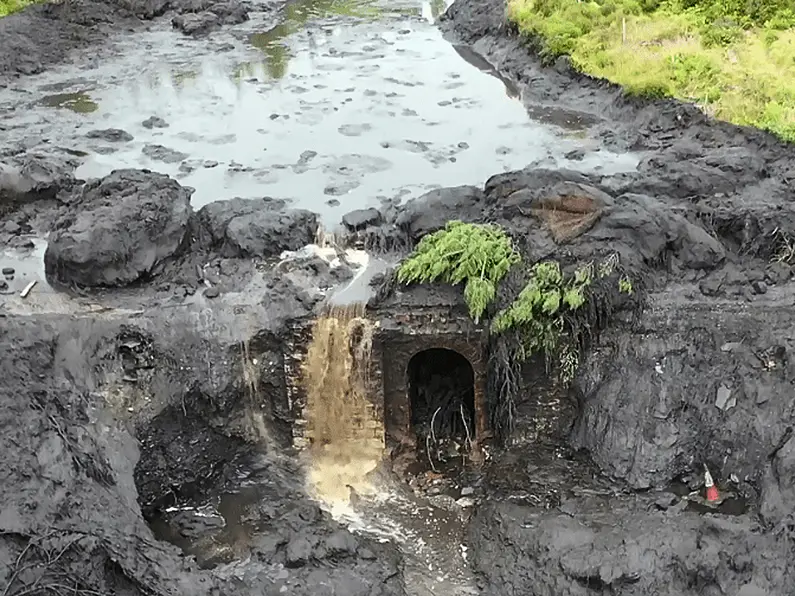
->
[[44, 170, 191, 287]]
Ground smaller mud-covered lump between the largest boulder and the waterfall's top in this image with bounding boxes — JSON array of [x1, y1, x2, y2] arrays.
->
[[197, 198, 318, 258]]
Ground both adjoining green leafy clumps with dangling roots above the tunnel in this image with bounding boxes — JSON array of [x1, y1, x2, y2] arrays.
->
[[397, 221, 635, 383]]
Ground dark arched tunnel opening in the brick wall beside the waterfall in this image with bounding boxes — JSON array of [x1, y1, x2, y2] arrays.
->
[[406, 348, 475, 468]]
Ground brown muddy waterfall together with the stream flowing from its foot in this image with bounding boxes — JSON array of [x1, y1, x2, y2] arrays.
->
[[304, 303, 478, 596]]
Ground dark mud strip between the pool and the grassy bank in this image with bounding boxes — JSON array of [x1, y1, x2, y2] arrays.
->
[[439, 0, 791, 158]]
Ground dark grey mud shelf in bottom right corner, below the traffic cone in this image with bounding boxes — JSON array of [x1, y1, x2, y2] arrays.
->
[[470, 496, 795, 596]]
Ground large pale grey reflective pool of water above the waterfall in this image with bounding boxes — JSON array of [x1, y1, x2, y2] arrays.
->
[[0, 0, 636, 233]]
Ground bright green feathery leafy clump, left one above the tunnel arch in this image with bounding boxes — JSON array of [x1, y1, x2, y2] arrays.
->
[[397, 221, 520, 323]]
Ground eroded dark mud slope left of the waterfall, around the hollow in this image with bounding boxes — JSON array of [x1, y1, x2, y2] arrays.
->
[[0, 318, 403, 596]]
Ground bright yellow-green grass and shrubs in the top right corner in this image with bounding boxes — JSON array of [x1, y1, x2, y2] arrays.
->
[[508, 0, 795, 141]]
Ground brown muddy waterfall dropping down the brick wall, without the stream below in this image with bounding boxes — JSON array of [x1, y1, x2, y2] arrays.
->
[[304, 303, 384, 513]]
